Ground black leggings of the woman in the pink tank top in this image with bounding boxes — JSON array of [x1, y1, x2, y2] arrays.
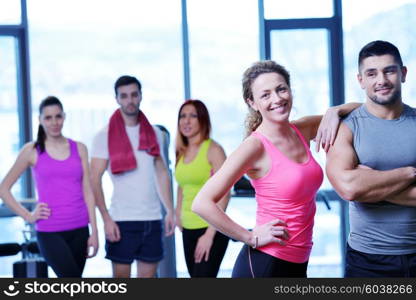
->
[[232, 245, 308, 278]]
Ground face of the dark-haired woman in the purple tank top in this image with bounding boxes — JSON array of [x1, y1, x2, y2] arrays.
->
[[39, 105, 65, 137]]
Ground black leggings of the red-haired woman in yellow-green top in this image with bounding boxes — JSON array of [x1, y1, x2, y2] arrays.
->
[[182, 228, 229, 277]]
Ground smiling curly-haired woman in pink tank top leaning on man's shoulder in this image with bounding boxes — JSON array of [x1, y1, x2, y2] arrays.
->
[[192, 61, 359, 277]]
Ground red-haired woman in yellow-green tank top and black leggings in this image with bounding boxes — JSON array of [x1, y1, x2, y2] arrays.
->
[[175, 100, 229, 277]]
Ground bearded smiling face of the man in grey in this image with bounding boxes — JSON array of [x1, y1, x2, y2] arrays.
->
[[357, 54, 407, 105]]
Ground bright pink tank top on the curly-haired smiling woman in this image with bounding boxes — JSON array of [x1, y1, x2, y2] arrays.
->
[[251, 124, 323, 263]]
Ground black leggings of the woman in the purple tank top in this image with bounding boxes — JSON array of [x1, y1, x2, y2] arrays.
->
[[36, 226, 89, 277]]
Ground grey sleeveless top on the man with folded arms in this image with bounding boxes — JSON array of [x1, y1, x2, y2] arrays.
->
[[343, 105, 416, 255]]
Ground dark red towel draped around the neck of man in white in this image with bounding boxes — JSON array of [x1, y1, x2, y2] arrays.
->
[[108, 109, 160, 174]]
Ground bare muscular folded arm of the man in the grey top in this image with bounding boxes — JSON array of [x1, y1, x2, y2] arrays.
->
[[326, 123, 415, 203]]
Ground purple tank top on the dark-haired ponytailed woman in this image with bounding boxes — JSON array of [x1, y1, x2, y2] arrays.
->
[[32, 139, 89, 232]]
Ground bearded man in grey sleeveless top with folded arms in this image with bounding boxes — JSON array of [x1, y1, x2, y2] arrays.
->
[[326, 41, 416, 277]]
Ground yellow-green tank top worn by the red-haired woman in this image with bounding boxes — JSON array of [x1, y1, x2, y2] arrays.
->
[[175, 139, 212, 229]]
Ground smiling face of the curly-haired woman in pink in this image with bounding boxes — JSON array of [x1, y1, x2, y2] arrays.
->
[[247, 73, 292, 122]]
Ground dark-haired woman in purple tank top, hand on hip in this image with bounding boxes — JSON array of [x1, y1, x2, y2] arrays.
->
[[0, 96, 98, 277]]
